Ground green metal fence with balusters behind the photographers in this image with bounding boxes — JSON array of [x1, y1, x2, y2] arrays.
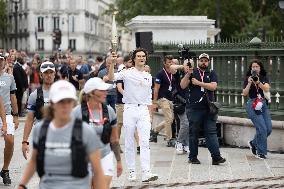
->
[[149, 41, 284, 120]]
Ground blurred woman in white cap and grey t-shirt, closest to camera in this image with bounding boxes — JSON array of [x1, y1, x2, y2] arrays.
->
[[18, 80, 106, 189]]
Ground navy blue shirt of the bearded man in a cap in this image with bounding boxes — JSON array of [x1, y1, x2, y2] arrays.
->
[[187, 68, 218, 109]]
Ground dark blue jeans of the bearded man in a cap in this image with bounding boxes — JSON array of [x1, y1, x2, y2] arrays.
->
[[186, 108, 221, 159]]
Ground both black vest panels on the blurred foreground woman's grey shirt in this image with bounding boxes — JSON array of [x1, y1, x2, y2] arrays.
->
[[36, 119, 88, 178]]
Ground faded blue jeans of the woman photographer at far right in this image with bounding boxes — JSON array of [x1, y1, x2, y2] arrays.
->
[[246, 99, 272, 155]]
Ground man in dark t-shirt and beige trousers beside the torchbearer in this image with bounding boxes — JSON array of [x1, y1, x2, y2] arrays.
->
[[151, 55, 175, 146]]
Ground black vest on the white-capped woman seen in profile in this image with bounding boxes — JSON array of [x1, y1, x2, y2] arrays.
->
[[81, 103, 112, 144]]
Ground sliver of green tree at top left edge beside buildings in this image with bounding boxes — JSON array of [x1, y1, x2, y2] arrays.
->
[[0, 0, 8, 47]]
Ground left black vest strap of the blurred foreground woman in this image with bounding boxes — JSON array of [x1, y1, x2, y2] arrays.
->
[[36, 120, 50, 177]]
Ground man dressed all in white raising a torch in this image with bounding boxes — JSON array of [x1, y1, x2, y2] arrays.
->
[[108, 48, 158, 182]]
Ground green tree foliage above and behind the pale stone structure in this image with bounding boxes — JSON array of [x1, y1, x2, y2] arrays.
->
[[110, 0, 284, 39]]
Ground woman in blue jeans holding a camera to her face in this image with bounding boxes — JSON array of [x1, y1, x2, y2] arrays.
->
[[243, 59, 272, 159]]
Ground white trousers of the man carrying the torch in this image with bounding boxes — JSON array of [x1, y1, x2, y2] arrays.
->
[[123, 104, 151, 171]]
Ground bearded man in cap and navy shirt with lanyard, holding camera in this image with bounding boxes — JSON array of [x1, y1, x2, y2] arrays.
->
[[180, 53, 226, 165]]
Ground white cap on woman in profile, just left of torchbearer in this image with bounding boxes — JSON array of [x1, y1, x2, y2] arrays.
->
[[83, 77, 112, 93]]
